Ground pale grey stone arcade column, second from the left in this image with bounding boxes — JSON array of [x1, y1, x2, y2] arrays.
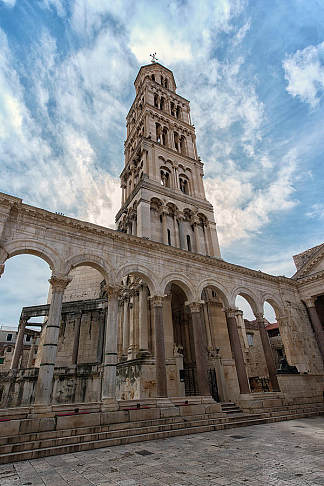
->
[[101, 285, 120, 404]]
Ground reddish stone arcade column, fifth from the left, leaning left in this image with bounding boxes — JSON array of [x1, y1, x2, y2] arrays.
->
[[225, 309, 250, 394]]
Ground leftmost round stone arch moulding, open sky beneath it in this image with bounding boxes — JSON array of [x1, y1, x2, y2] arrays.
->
[[2, 240, 64, 273]]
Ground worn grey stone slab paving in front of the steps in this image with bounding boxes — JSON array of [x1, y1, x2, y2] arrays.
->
[[0, 417, 324, 486]]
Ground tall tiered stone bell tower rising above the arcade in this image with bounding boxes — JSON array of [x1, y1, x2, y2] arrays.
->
[[116, 62, 220, 258]]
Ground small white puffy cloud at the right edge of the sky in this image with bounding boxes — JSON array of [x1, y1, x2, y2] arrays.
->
[[283, 42, 324, 108]]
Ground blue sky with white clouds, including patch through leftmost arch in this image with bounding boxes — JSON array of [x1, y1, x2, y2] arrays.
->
[[0, 0, 324, 324]]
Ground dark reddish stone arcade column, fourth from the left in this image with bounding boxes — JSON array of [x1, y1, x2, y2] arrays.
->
[[189, 302, 210, 395]]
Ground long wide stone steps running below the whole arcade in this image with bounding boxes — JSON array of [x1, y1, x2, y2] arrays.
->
[[0, 403, 323, 464]]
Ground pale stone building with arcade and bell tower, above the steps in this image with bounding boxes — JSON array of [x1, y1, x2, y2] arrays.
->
[[0, 63, 324, 411]]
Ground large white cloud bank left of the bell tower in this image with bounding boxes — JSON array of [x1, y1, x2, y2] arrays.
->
[[0, 28, 122, 227]]
